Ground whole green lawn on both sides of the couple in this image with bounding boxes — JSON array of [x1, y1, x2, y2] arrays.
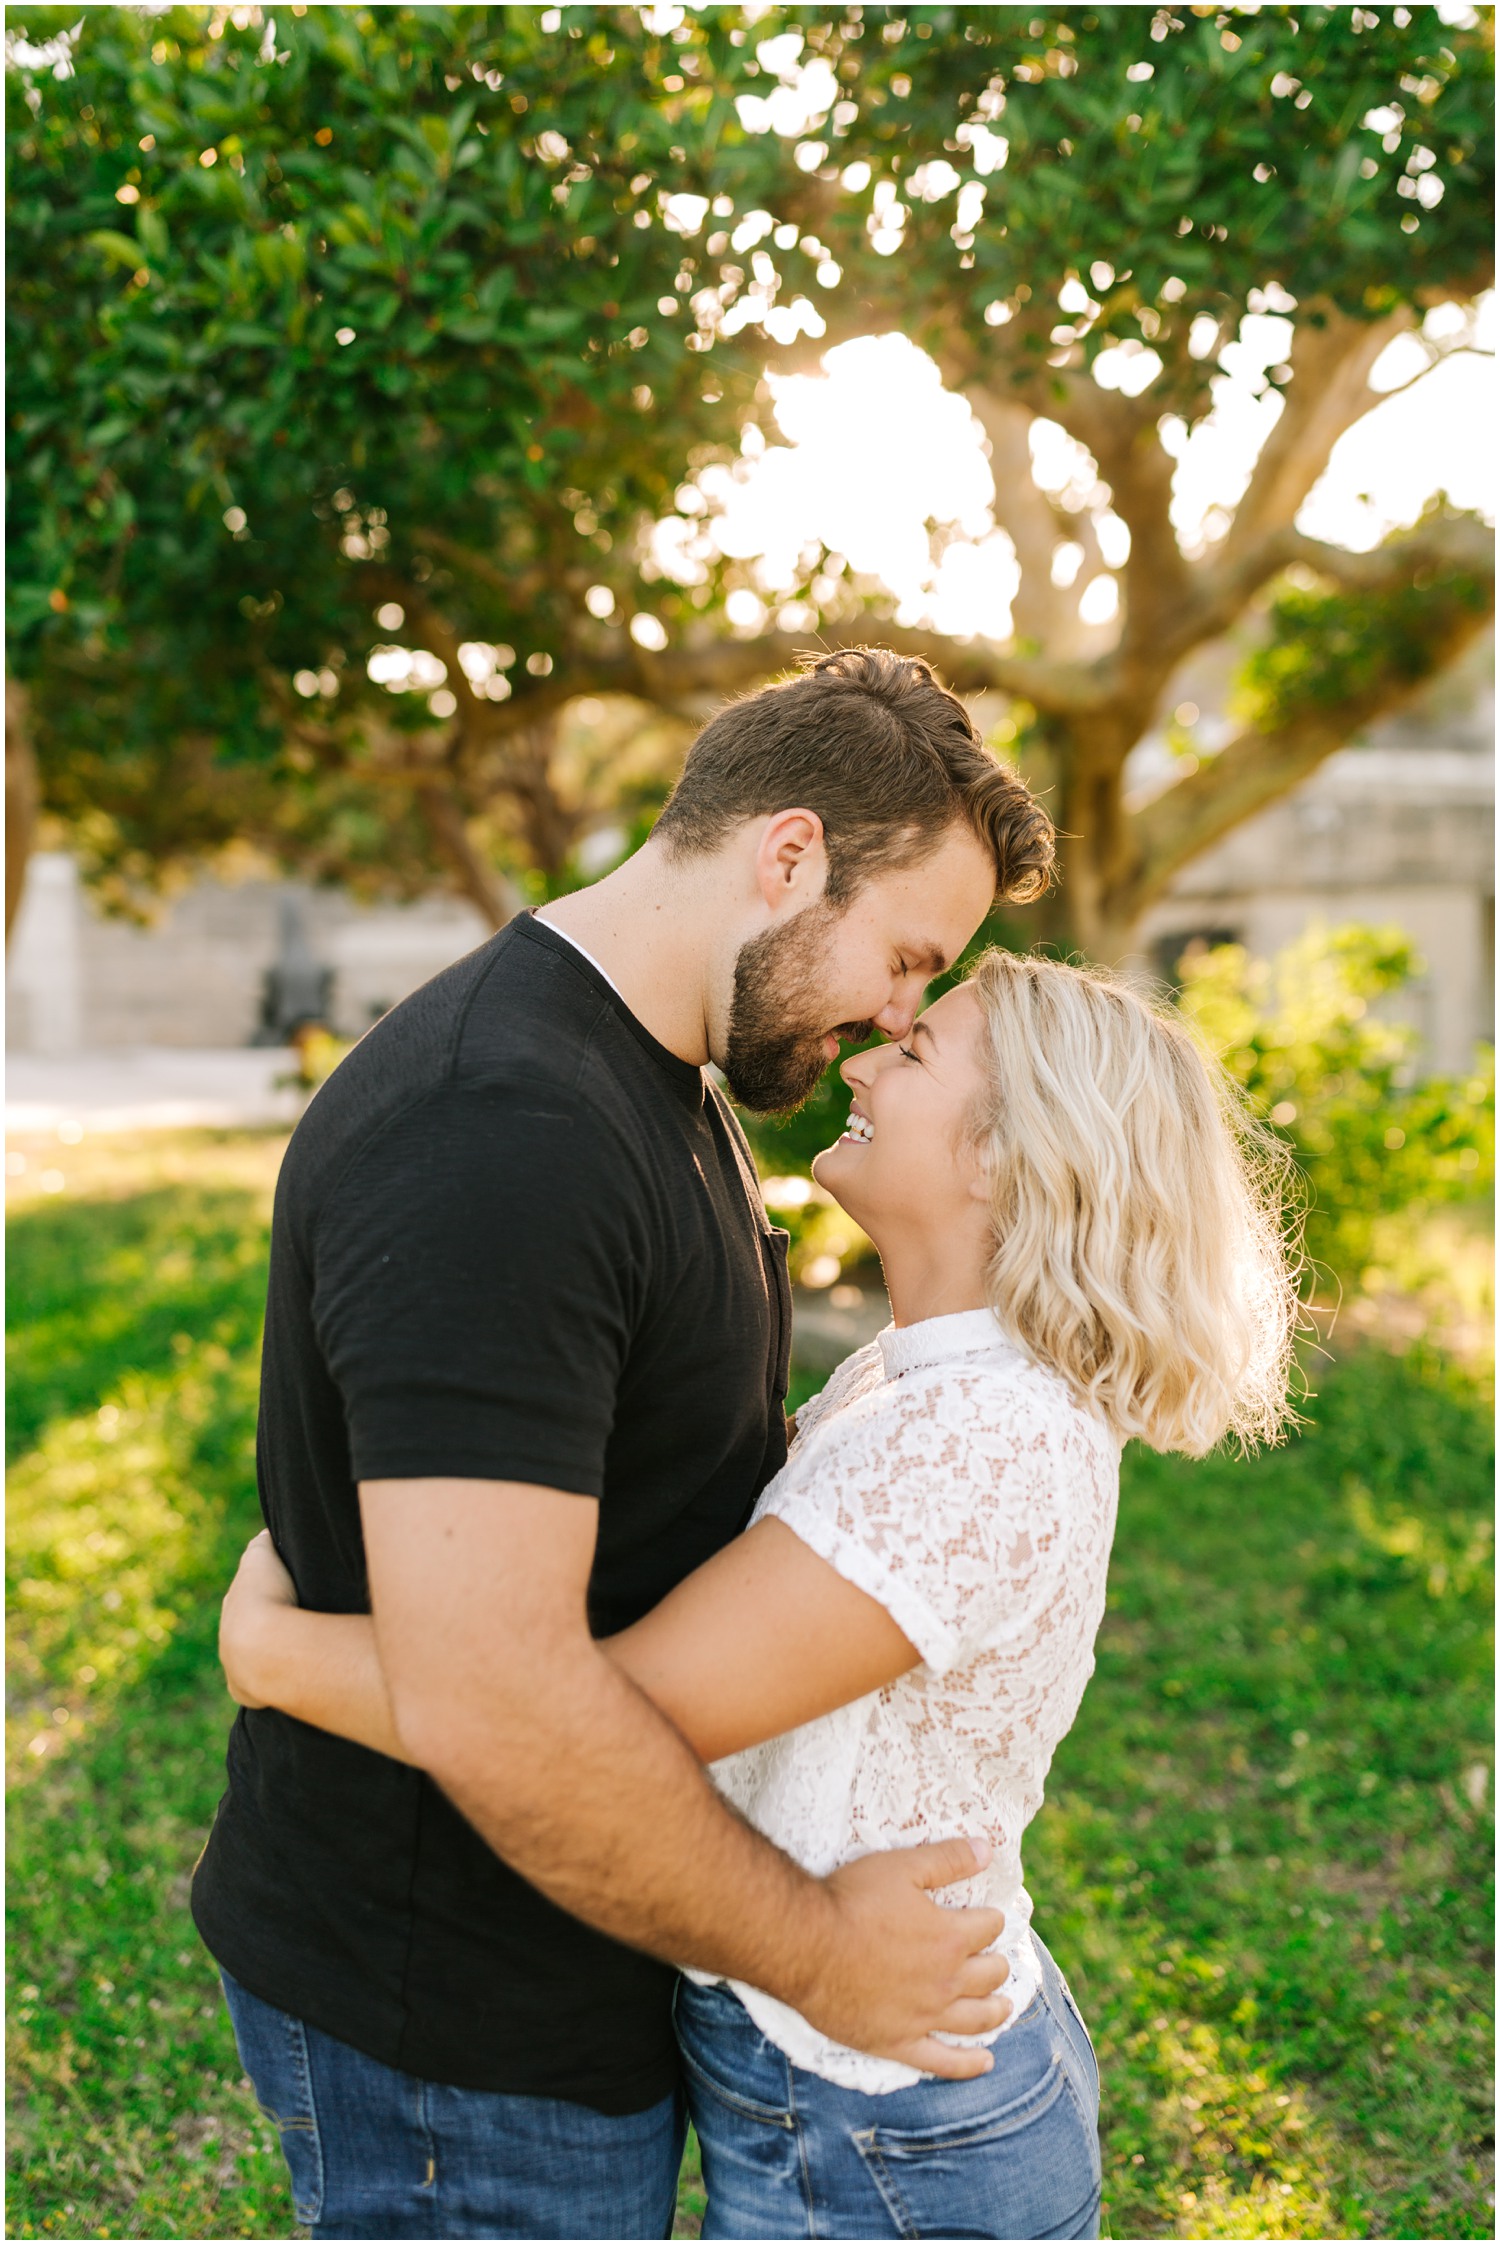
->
[[9, 1134, 1493, 2238]]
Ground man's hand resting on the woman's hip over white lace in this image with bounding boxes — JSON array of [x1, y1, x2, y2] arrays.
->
[[797, 1839, 1010, 2081]]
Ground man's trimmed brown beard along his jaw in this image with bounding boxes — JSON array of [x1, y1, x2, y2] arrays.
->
[[723, 905, 874, 1114]]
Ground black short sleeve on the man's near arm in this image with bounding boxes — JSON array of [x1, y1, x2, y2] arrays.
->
[[312, 1084, 649, 1497]]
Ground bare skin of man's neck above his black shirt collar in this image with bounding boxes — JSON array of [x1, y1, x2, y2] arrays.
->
[[537, 842, 712, 1069]]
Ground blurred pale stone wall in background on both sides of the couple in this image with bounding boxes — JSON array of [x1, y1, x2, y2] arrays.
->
[[7, 703, 1496, 1073]]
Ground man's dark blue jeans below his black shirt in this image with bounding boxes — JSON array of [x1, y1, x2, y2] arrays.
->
[[222, 1973, 687, 2238]]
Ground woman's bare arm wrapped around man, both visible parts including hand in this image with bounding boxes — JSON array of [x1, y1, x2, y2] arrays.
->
[[218, 1520, 918, 1762]]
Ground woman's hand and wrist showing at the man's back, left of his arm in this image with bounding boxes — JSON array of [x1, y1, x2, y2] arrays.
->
[[218, 1529, 411, 1762]]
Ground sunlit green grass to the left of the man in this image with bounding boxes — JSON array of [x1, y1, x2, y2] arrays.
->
[[7, 1140, 292, 2238]]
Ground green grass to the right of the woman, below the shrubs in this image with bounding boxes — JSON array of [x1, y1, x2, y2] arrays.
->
[[1026, 1347, 1493, 2238]]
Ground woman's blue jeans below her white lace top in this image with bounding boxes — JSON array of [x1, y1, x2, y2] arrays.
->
[[676, 1942, 1100, 2238]]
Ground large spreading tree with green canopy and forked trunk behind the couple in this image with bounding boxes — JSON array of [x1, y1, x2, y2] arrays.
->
[[11, 4, 1493, 956]]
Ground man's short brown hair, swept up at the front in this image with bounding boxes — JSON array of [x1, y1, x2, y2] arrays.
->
[[656, 647, 1053, 905]]
